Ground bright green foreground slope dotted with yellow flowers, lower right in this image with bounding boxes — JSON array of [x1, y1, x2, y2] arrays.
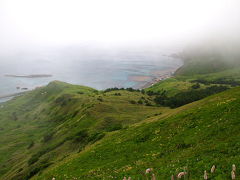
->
[[33, 88, 240, 179]]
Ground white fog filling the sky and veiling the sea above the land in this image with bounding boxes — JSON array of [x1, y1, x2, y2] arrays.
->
[[0, 0, 240, 98]]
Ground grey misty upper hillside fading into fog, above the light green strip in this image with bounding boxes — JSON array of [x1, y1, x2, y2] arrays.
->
[[175, 41, 240, 75]]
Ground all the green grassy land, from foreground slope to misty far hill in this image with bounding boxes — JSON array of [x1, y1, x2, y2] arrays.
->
[[0, 50, 240, 180]]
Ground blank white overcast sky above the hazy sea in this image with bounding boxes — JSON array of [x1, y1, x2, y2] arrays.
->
[[0, 0, 240, 49]]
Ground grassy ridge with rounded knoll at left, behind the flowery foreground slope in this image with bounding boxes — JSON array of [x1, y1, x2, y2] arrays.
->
[[0, 82, 166, 179]]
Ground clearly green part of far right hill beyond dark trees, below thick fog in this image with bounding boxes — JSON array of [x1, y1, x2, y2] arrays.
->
[[146, 56, 240, 97]]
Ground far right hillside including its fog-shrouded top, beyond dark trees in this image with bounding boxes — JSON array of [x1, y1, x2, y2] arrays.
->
[[146, 41, 240, 97]]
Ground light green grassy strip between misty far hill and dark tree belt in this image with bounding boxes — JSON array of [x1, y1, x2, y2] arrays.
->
[[145, 67, 240, 97]]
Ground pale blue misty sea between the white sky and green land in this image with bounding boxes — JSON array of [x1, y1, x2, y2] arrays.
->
[[0, 47, 182, 101]]
